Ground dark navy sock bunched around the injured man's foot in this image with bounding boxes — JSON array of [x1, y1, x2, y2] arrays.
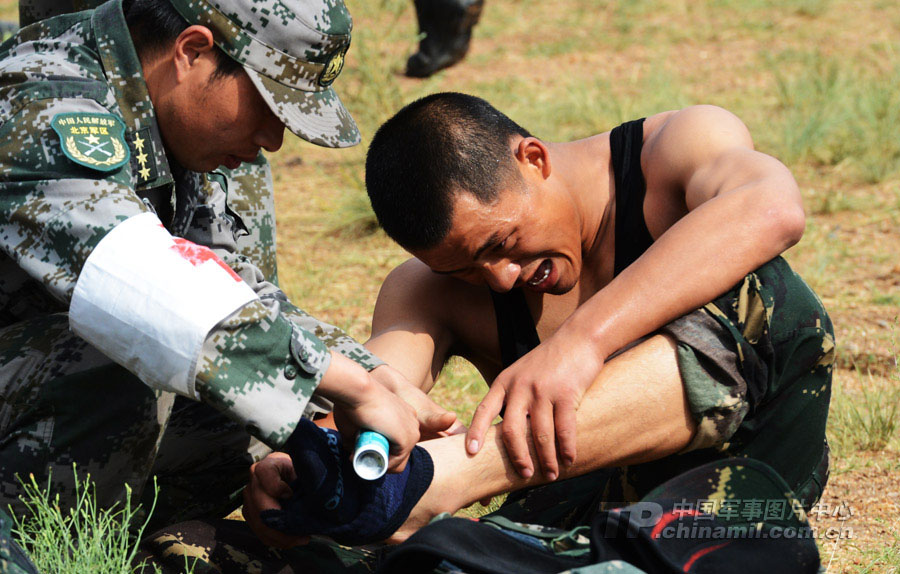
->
[[261, 419, 434, 545]]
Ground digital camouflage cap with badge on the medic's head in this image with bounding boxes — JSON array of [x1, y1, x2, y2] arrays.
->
[[169, 0, 360, 147]]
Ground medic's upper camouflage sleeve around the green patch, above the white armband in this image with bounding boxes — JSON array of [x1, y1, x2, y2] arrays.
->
[[0, 98, 147, 309]]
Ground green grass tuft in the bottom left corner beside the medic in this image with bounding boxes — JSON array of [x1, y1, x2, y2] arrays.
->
[[13, 467, 186, 574]]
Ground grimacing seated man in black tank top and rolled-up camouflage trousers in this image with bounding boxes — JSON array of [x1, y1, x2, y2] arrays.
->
[[356, 94, 834, 516]]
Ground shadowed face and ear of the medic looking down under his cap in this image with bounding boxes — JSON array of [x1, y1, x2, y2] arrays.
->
[[151, 26, 284, 172]]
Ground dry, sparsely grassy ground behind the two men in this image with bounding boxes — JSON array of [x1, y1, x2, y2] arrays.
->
[[0, 0, 900, 573]]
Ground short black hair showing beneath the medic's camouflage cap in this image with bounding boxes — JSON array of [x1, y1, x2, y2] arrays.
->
[[122, 0, 243, 82]]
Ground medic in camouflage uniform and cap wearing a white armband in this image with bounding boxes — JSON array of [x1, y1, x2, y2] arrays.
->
[[0, 0, 454, 536]]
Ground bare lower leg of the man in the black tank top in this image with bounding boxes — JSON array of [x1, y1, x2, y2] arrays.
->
[[389, 335, 696, 542]]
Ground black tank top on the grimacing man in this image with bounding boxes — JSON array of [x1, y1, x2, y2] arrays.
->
[[491, 118, 653, 368]]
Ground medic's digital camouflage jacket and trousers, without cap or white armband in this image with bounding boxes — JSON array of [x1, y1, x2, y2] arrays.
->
[[0, 0, 381, 519]]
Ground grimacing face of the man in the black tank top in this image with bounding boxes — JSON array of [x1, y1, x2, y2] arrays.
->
[[413, 182, 582, 295]]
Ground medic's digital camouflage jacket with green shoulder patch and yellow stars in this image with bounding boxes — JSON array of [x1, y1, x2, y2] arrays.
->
[[0, 0, 380, 447]]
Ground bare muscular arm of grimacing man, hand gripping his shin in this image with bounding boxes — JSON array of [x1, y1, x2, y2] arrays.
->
[[467, 106, 805, 480]]
